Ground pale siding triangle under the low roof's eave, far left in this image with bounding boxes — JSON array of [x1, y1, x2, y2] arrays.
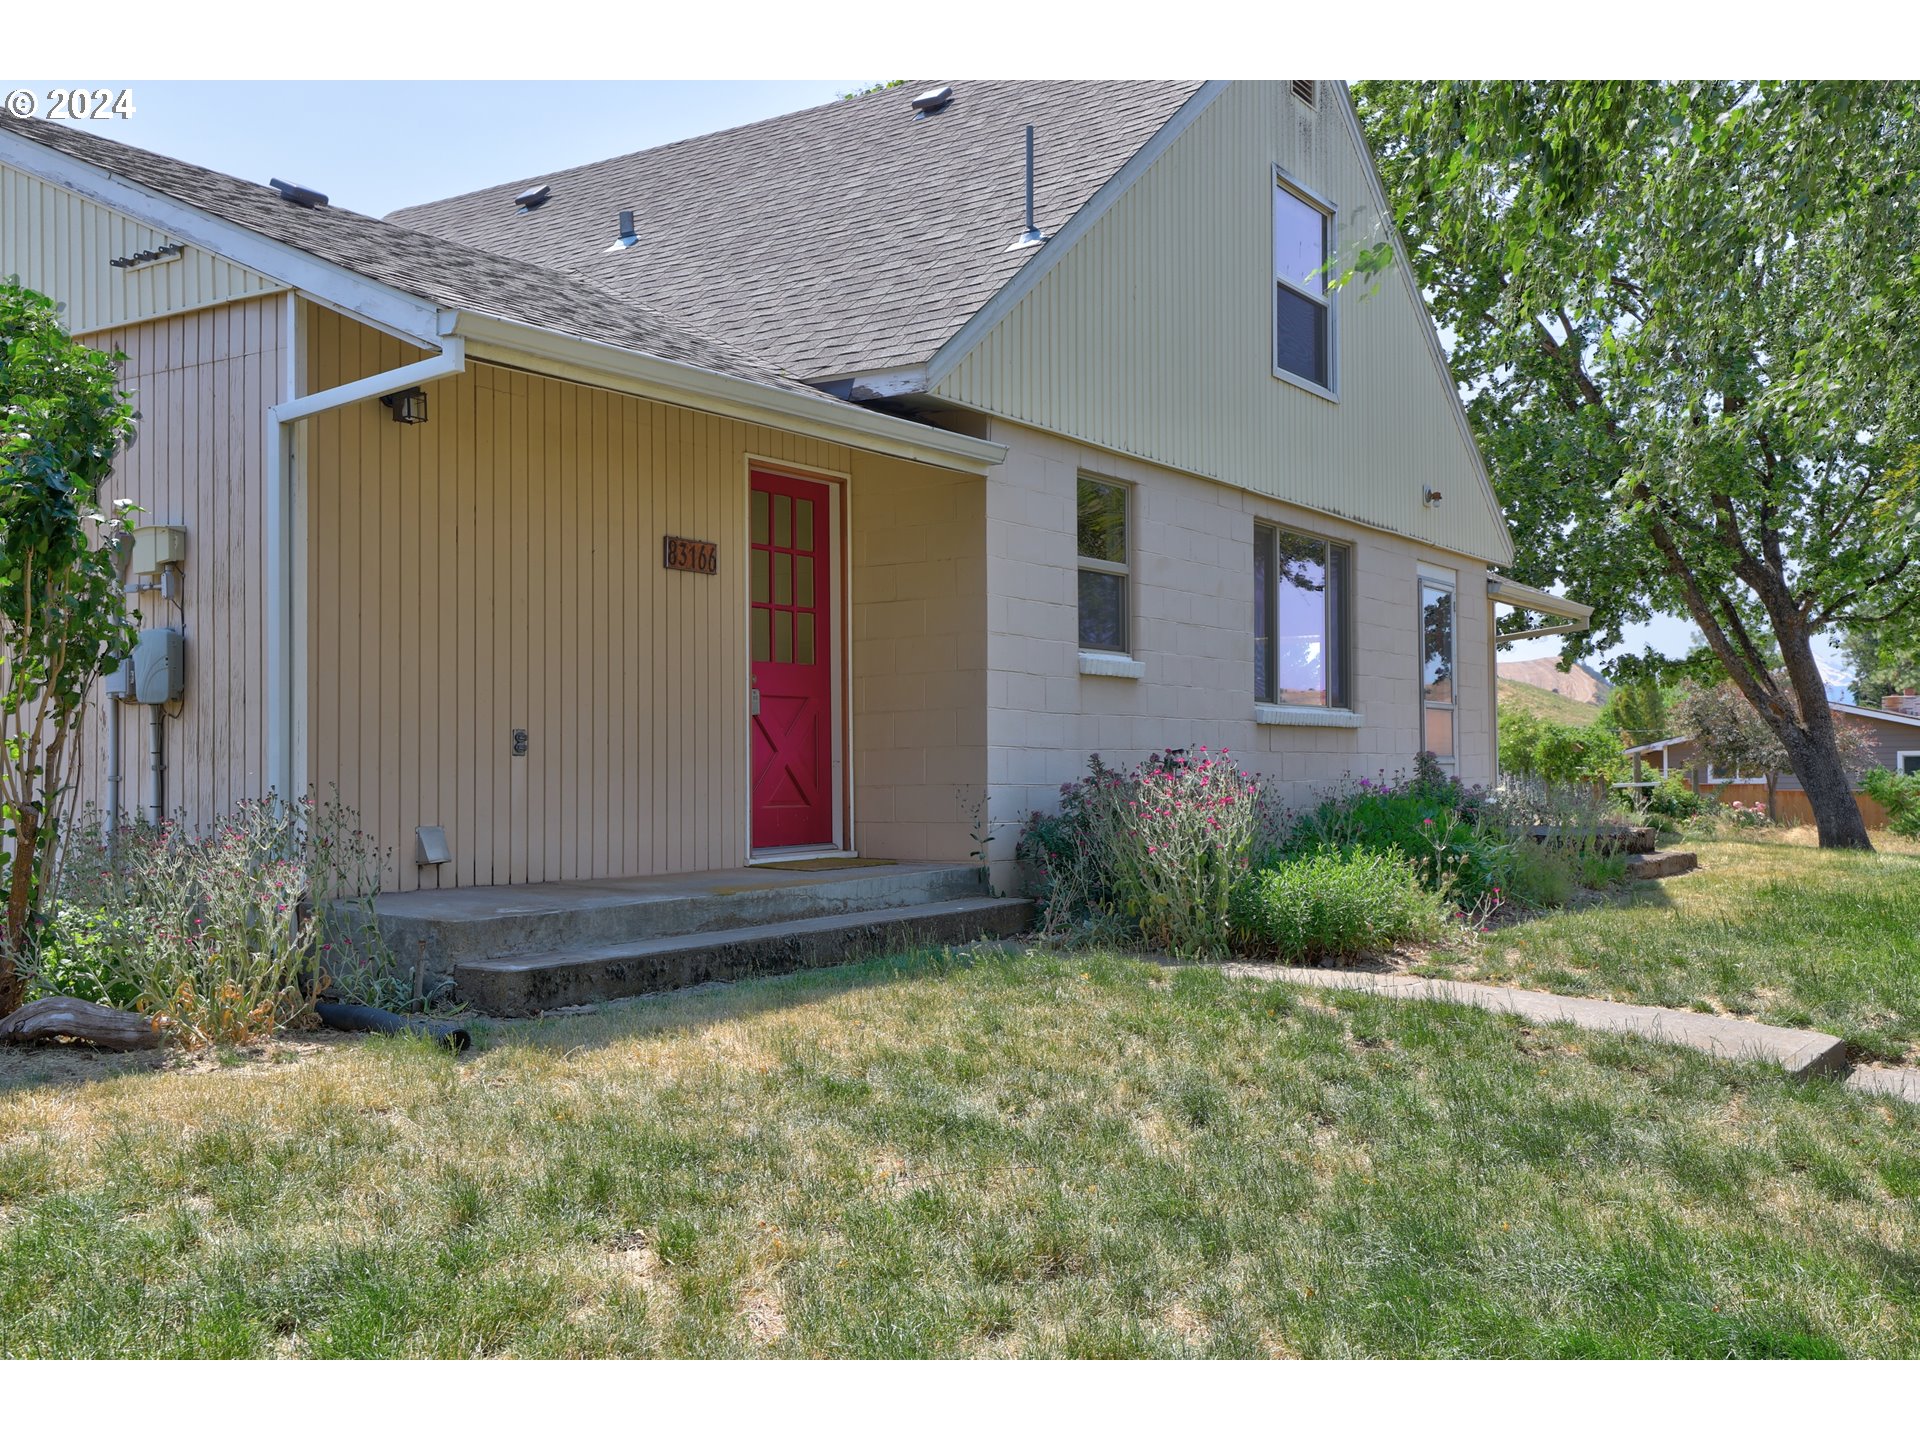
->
[[0, 165, 284, 334]]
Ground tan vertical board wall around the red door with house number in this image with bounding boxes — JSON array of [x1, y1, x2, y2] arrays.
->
[[309, 309, 987, 889]]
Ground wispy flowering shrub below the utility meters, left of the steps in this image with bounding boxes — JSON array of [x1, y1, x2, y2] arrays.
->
[[33, 799, 403, 1046]]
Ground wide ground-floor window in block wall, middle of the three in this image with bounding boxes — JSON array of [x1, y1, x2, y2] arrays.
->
[[1254, 524, 1352, 710]]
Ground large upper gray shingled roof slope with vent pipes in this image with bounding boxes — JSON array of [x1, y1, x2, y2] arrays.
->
[[394, 81, 1198, 378]]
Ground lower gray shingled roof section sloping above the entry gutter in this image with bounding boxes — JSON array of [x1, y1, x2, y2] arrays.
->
[[0, 111, 820, 396]]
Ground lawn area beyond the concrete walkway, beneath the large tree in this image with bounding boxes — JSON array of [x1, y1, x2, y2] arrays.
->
[[1425, 831, 1920, 1062]]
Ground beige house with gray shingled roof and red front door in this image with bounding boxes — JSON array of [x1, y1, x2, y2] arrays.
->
[[0, 81, 1586, 889]]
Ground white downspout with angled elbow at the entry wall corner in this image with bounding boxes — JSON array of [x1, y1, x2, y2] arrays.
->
[[265, 305, 467, 801]]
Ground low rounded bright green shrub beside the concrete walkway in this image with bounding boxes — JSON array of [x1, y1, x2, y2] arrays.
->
[[1233, 849, 1448, 960]]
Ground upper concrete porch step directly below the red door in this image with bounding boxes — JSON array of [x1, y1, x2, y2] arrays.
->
[[376, 864, 987, 975]]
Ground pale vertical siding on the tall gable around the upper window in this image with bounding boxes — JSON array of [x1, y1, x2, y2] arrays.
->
[[935, 81, 1509, 563]]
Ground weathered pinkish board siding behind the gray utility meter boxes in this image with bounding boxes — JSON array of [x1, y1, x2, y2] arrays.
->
[[81, 298, 284, 826]]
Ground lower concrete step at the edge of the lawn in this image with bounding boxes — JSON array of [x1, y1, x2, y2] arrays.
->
[[453, 897, 1033, 1016]]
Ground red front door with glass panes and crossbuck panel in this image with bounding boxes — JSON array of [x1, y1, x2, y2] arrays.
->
[[747, 472, 833, 849]]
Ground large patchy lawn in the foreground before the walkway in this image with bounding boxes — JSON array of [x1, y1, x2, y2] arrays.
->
[[0, 952, 1920, 1356]]
